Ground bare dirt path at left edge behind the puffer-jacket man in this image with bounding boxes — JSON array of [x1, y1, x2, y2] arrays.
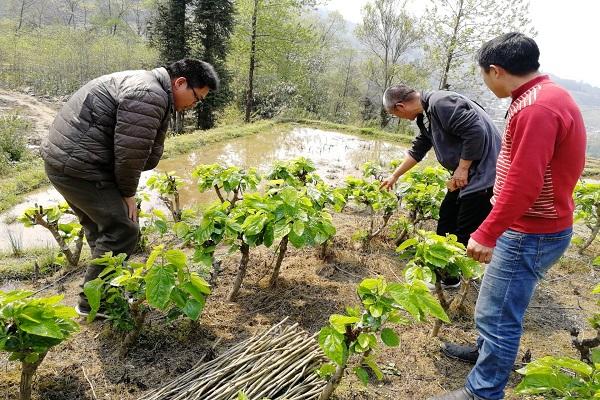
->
[[0, 89, 58, 144]]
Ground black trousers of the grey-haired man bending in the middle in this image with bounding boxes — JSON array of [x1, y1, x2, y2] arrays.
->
[[436, 188, 493, 284]]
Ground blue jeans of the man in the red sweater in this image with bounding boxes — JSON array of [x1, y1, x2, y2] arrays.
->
[[465, 228, 573, 400]]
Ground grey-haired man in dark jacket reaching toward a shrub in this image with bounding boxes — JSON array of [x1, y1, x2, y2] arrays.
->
[[381, 84, 502, 287]]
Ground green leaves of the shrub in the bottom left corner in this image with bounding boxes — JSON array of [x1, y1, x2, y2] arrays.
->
[[0, 290, 79, 364]]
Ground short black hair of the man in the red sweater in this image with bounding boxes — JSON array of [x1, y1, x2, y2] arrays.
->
[[477, 32, 540, 76]]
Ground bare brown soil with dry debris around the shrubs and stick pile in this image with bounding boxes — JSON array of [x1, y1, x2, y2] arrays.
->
[[0, 209, 600, 400]]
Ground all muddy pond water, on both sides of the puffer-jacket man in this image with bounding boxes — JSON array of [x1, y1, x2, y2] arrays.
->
[[0, 128, 405, 250]]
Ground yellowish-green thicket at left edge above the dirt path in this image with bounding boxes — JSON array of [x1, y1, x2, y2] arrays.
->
[[0, 23, 157, 94]]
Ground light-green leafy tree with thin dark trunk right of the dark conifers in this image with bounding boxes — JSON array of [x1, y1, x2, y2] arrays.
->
[[230, 0, 316, 122]]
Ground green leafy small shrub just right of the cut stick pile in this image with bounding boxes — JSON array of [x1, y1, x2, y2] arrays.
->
[[318, 278, 448, 384]]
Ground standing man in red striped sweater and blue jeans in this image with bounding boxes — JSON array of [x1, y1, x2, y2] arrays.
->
[[433, 33, 586, 400]]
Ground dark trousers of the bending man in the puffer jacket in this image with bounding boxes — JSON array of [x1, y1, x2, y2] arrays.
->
[[46, 165, 139, 304]]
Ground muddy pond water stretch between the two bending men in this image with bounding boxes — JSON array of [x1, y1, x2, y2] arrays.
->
[[157, 128, 405, 207]]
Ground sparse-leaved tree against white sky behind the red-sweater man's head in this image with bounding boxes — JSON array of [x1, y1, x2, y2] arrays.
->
[[423, 0, 535, 91]]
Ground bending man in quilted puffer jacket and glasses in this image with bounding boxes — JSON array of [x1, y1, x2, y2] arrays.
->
[[41, 59, 219, 315]]
